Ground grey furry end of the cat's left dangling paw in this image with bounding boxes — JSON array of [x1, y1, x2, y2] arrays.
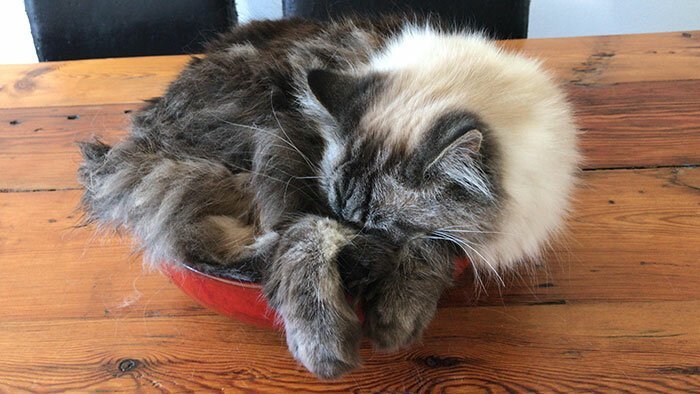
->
[[286, 316, 362, 379]]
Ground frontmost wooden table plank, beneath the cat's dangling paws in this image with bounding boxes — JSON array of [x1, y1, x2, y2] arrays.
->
[[0, 301, 700, 393]]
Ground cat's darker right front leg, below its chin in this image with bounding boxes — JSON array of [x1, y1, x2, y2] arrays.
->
[[363, 241, 454, 351]]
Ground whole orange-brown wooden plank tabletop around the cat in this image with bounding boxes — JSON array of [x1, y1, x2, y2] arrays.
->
[[0, 31, 700, 392]]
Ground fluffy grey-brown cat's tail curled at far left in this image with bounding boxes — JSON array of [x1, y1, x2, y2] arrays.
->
[[78, 138, 262, 280]]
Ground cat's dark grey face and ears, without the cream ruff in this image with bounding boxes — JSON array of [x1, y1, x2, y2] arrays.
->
[[309, 71, 497, 243]]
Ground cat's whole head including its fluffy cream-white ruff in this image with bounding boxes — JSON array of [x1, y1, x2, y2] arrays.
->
[[299, 30, 581, 268]]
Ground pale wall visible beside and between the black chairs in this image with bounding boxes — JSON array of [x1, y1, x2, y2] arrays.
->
[[0, 0, 700, 64]]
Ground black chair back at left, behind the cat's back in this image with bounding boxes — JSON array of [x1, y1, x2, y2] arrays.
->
[[24, 0, 236, 61]]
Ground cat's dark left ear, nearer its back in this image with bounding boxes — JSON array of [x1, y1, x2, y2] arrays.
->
[[306, 69, 365, 120]]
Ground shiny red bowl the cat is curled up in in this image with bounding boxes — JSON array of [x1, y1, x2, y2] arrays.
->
[[161, 259, 469, 329]]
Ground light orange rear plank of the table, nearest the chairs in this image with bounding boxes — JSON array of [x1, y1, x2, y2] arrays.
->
[[0, 31, 700, 108]]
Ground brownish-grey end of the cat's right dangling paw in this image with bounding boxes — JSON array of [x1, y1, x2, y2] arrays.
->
[[364, 296, 437, 351]]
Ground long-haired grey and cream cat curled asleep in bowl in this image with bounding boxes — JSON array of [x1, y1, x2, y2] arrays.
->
[[78, 17, 581, 378]]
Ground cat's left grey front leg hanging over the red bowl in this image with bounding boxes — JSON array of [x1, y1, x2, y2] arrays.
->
[[264, 215, 362, 378]]
